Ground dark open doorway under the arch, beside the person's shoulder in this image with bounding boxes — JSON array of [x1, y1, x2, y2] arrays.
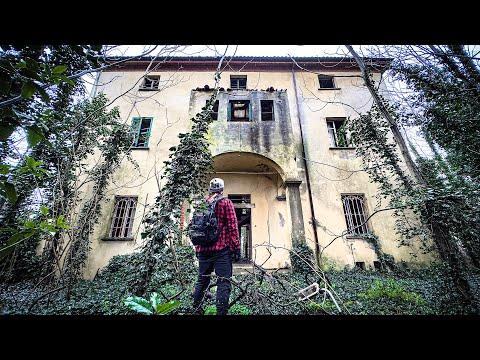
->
[[228, 194, 252, 263]]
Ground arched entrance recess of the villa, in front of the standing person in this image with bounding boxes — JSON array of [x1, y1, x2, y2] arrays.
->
[[209, 152, 291, 268]]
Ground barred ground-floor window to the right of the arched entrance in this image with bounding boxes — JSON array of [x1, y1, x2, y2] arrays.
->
[[342, 195, 370, 236]]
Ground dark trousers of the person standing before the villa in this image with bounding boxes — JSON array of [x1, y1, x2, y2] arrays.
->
[[193, 247, 232, 315]]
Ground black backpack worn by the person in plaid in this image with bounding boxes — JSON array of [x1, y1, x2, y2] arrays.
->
[[188, 196, 224, 246]]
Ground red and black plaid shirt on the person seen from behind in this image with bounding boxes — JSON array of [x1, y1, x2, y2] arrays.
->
[[195, 194, 240, 252]]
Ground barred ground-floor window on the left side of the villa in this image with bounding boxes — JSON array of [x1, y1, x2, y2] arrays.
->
[[109, 196, 137, 239]]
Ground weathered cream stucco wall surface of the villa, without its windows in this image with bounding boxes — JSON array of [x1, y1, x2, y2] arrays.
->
[[79, 66, 436, 278]]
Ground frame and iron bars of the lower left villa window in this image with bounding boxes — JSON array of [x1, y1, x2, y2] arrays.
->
[[105, 195, 138, 240]]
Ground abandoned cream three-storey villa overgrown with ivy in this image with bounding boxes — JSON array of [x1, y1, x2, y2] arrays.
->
[[77, 57, 431, 278]]
